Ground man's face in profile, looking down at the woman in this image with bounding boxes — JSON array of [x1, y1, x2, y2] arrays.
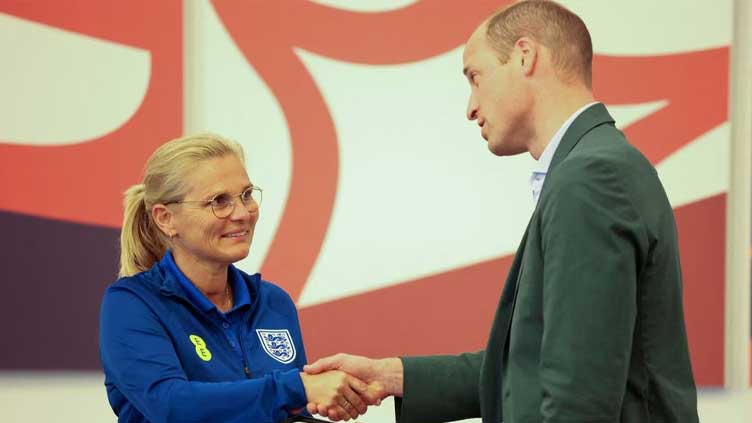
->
[[462, 25, 534, 156]]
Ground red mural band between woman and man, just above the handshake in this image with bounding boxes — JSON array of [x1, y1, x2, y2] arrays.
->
[[300, 256, 512, 362]]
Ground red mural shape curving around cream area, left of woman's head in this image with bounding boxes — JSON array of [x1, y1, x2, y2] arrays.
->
[[0, 0, 183, 228]]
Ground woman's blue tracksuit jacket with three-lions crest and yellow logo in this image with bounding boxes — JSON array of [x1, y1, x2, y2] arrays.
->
[[99, 252, 306, 423]]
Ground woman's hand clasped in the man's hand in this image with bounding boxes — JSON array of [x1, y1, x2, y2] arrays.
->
[[300, 370, 368, 421]]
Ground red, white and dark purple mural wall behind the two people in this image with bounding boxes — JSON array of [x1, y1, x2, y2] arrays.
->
[[0, 0, 732, 394]]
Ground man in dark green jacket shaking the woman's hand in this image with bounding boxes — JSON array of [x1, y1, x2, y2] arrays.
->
[[306, 1, 698, 423]]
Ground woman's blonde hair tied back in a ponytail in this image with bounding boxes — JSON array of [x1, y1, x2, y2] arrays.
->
[[119, 134, 245, 277]]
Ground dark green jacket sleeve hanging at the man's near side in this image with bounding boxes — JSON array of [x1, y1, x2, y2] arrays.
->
[[540, 158, 648, 422]]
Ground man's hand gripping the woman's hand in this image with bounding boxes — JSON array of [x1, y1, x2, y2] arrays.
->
[[303, 353, 403, 420]]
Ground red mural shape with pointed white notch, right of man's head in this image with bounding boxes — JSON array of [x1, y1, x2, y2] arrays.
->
[[593, 47, 729, 164]]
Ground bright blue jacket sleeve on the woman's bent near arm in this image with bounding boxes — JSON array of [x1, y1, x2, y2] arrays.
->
[[100, 288, 306, 423]]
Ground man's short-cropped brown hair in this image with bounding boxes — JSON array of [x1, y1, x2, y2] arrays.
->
[[486, 0, 593, 88]]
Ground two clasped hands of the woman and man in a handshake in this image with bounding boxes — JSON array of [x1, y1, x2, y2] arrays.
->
[[300, 354, 403, 421]]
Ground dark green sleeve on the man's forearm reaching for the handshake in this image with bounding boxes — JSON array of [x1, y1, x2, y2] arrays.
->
[[395, 351, 483, 423]]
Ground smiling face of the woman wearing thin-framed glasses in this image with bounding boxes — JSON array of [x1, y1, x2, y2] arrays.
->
[[169, 155, 259, 266]]
